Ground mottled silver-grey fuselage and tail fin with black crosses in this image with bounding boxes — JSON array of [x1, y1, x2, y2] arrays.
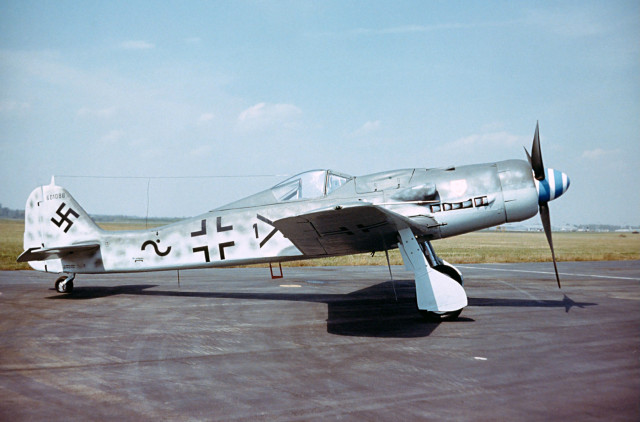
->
[[24, 160, 538, 273]]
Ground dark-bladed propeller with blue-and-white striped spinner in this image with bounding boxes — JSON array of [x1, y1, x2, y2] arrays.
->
[[525, 123, 570, 288]]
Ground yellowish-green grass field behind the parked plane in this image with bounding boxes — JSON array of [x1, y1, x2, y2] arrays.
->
[[0, 219, 640, 270]]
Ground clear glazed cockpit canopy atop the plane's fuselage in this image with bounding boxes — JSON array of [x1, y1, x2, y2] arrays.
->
[[271, 170, 353, 202]]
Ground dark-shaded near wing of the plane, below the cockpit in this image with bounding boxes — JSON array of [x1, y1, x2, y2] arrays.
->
[[273, 203, 440, 255]]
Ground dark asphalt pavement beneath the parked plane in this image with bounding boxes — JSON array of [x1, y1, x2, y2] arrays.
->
[[0, 261, 640, 421]]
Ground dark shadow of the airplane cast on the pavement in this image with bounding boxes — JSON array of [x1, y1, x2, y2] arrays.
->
[[49, 280, 596, 338]]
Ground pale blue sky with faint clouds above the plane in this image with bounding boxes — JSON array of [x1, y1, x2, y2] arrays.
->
[[0, 1, 640, 225]]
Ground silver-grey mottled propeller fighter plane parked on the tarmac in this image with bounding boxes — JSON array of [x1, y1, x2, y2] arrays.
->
[[18, 125, 569, 319]]
